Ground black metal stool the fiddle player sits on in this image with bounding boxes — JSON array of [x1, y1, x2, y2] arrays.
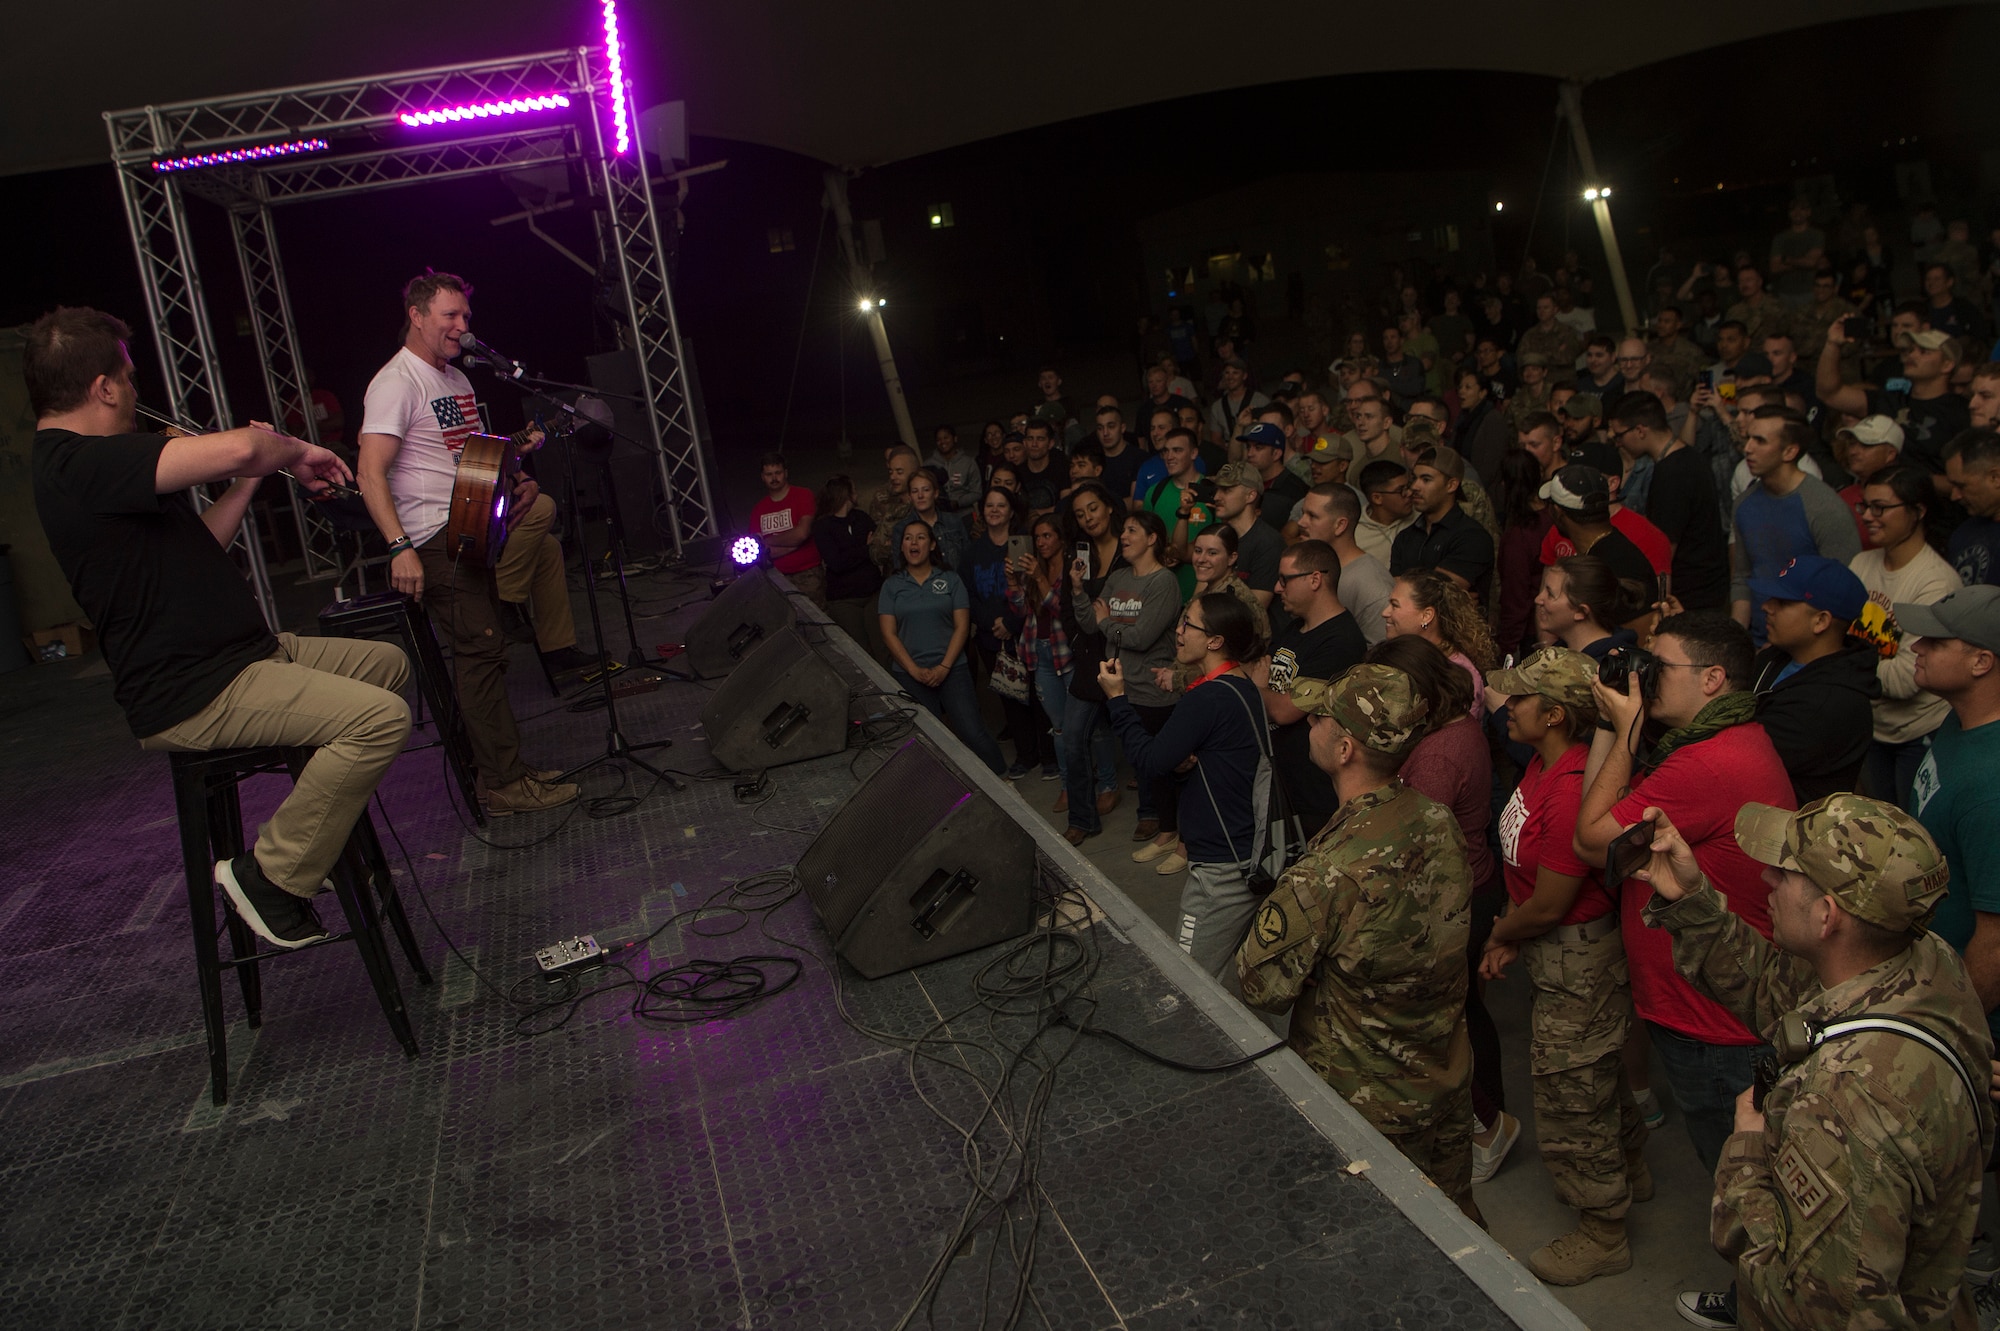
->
[[170, 745, 430, 1105]]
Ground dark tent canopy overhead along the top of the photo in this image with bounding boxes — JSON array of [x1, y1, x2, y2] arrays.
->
[[0, 0, 1960, 174]]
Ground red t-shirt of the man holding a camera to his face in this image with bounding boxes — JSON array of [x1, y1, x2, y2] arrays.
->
[[1612, 721, 1798, 1045]]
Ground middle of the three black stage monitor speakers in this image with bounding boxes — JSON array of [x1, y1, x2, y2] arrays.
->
[[702, 628, 848, 771]]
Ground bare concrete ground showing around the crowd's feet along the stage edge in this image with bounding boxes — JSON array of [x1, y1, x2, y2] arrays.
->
[[1000, 755, 1730, 1331]]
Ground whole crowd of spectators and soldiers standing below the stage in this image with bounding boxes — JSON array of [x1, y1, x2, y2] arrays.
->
[[736, 202, 2000, 1327]]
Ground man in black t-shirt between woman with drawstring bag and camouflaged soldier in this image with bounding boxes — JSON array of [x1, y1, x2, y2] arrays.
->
[[1250, 542, 1368, 837]]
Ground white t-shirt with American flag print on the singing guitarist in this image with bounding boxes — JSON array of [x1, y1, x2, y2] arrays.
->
[[362, 348, 480, 546]]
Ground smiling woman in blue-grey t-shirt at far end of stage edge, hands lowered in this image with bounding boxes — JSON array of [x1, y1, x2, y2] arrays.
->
[[878, 518, 1006, 775]]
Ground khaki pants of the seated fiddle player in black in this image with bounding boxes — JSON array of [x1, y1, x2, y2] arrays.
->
[[140, 634, 410, 897]]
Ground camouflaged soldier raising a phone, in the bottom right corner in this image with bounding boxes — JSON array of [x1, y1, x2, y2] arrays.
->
[[1646, 795, 1994, 1327]]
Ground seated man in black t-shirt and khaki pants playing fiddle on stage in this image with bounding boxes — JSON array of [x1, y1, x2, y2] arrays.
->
[[24, 308, 410, 947]]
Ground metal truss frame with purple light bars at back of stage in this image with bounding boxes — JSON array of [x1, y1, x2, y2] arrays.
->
[[104, 46, 718, 628]]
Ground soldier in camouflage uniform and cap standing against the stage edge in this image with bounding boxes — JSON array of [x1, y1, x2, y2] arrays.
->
[[1236, 666, 1480, 1219]]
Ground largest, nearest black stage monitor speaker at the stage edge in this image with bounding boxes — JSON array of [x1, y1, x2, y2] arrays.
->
[[798, 739, 1036, 979]]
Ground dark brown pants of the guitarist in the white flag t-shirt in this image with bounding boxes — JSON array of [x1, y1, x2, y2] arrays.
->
[[416, 528, 532, 789]]
